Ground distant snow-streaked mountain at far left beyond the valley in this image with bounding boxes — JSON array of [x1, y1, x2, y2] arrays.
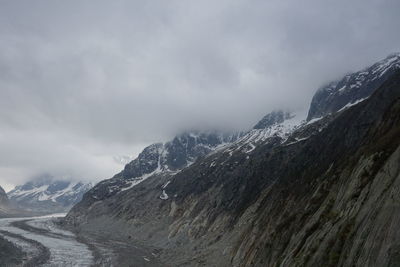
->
[[8, 175, 92, 213]]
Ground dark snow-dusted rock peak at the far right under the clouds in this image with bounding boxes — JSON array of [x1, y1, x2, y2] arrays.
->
[[307, 53, 400, 120]]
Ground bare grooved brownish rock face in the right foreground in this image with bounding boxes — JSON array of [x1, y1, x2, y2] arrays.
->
[[233, 71, 400, 266]]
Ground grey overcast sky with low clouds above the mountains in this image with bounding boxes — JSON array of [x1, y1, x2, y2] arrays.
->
[[0, 0, 400, 189]]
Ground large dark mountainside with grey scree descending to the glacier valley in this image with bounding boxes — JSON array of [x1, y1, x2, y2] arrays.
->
[[65, 55, 400, 266]]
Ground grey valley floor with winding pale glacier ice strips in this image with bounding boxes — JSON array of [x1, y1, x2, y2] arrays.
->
[[0, 214, 161, 266]]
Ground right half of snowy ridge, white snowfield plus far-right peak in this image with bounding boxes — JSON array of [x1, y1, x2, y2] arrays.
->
[[244, 53, 400, 150]]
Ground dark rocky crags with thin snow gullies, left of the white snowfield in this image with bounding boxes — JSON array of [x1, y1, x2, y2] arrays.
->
[[90, 131, 241, 200]]
